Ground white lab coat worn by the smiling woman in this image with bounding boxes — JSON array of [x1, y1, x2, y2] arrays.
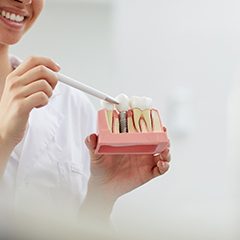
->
[[0, 58, 96, 216]]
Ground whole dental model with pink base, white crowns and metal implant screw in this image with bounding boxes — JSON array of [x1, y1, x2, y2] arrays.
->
[[96, 94, 169, 154]]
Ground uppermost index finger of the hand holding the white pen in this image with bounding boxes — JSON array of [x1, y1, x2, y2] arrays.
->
[[14, 56, 60, 76]]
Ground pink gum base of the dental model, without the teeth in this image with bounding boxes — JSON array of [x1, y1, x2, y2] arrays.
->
[[95, 109, 169, 154]]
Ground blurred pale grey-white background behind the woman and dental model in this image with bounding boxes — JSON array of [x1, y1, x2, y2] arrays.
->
[[11, 0, 240, 240]]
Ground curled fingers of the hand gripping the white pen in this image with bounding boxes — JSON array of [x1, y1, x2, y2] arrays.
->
[[4, 57, 60, 114]]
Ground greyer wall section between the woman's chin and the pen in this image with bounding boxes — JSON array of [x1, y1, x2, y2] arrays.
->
[[11, 0, 112, 106]]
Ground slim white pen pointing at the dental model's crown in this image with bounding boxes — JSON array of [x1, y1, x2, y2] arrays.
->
[[57, 73, 119, 104]]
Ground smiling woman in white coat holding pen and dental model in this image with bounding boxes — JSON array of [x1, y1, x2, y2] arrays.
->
[[0, 0, 170, 232]]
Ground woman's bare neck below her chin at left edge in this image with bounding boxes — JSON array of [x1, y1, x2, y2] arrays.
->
[[0, 44, 12, 99]]
